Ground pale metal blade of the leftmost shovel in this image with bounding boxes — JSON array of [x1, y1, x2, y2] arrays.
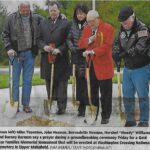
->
[[3, 101, 18, 118]]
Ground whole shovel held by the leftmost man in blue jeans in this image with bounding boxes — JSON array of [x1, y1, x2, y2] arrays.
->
[[3, 57, 18, 118]]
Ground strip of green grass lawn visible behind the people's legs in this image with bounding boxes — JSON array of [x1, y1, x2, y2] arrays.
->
[[0, 74, 122, 89]]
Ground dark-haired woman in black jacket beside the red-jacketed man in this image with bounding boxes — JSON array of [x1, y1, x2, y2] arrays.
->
[[67, 4, 88, 117]]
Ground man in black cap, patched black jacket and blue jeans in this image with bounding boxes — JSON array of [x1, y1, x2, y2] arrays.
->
[[113, 6, 150, 127]]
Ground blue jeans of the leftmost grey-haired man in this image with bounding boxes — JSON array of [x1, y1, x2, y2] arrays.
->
[[13, 50, 35, 106]]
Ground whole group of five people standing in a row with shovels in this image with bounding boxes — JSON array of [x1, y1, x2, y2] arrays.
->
[[2, 1, 150, 127]]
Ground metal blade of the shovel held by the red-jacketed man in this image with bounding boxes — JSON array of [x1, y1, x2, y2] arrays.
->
[[84, 105, 98, 125]]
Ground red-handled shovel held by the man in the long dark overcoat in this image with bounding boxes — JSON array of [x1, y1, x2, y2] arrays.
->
[[44, 53, 55, 116]]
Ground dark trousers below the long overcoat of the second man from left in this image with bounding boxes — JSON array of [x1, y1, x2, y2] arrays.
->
[[45, 79, 68, 110]]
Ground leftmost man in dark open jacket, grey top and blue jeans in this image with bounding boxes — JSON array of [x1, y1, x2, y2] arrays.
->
[[2, 2, 42, 113]]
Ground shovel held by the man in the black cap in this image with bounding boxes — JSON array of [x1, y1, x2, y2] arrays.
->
[[116, 62, 126, 120]]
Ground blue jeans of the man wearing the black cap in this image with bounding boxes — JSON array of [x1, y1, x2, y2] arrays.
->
[[123, 65, 150, 122]]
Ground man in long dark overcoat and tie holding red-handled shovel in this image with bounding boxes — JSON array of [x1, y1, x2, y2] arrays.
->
[[38, 1, 70, 114]]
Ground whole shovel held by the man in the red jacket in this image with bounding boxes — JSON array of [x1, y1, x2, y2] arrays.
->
[[84, 56, 99, 125]]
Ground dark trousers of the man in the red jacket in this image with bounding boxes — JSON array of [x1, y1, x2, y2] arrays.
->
[[90, 64, 112, 119]]
